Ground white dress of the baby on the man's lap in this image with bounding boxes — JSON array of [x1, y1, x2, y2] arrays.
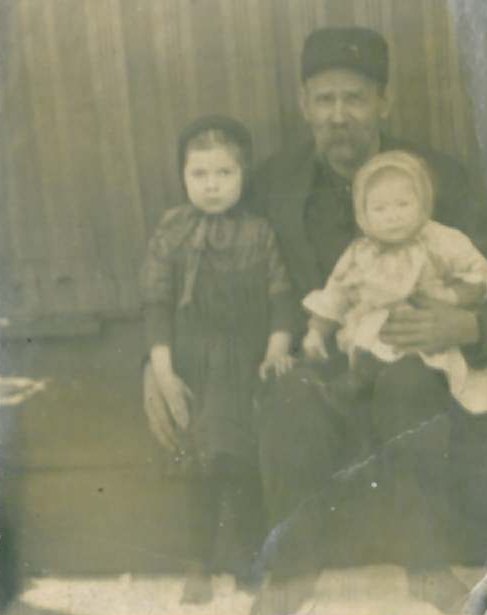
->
[[303, 221, 487, 413]]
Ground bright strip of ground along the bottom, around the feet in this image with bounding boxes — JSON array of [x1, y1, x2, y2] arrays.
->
[[8, 566, 482, 615]]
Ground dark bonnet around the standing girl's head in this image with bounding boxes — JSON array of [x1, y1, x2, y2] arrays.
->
[[178, 115, 252, 179]]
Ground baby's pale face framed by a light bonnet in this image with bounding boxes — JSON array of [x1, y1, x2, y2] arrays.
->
[[365, 173, 423, 244]]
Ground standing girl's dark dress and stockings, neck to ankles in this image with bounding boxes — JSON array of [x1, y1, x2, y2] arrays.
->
[[143, 205, 291, 579]]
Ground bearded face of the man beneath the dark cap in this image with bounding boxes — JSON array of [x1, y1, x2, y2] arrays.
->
[[301, 68, 389, 168]]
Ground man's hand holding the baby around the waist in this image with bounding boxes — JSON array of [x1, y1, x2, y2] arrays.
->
[[380, 299, 480, 354]]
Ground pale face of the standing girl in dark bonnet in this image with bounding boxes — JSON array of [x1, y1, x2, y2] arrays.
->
[[184, 145, 243, 214]]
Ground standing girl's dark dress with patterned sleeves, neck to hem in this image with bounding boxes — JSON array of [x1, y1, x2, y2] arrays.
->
[[143, 205, 290, 468]]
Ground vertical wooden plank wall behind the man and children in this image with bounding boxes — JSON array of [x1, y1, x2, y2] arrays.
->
[[0, 0, 476, 320]]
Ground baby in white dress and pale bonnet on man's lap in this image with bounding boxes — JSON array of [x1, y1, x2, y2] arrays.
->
[[303, 151, 487, 413]]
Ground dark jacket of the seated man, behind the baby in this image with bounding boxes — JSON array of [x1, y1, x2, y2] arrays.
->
[[254, 136, 487, 365]]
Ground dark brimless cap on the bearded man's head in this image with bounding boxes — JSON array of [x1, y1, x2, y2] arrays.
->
[[301, 27, 389, 85]]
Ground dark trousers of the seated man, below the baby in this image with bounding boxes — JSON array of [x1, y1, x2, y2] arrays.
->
[[259, 356, 458, 577]]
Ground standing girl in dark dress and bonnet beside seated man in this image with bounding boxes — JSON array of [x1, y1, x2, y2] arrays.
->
[[143, 116, 292, 602]]
